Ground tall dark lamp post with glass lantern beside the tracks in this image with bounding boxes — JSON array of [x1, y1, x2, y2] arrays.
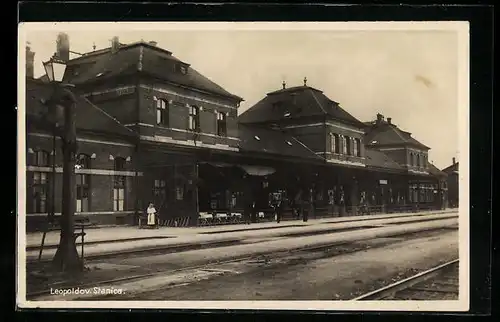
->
[[43, 57, 82, 271]]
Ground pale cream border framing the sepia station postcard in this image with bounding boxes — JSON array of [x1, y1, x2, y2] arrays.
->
[[16, 21, 470, 312]]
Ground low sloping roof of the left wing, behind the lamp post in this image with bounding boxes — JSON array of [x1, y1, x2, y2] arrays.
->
[[25, 80, 136, 137]]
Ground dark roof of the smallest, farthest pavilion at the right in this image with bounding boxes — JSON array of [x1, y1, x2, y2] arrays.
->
[[364, 119, 430, 150]]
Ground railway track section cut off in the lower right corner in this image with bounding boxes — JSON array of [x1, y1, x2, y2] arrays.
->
[[353, 259, 459, 301]]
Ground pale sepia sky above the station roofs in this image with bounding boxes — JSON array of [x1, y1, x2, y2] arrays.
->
[[20, 24, 460, 169]]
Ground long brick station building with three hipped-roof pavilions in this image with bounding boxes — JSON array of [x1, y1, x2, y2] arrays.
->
[[26, 34, 446, 229]]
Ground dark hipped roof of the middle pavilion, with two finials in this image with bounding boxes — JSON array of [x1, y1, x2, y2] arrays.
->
[[239, 86, 364, 128]]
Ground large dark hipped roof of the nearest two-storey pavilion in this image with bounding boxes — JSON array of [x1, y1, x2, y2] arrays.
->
[[65, 42, 243, 101]]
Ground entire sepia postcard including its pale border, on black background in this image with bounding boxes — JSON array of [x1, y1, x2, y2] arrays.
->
[[17, 21, 469, 311]]
